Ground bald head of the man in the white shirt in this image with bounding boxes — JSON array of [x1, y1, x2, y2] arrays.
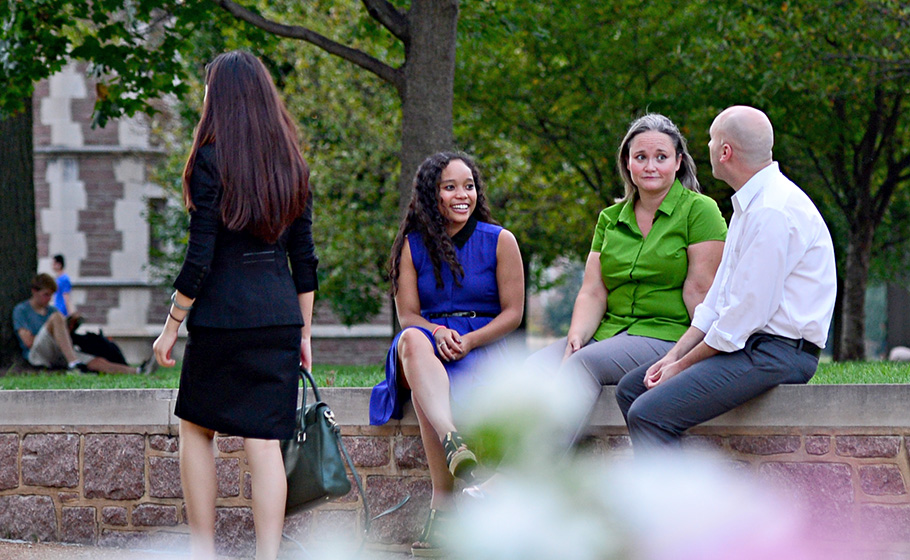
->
[[711, 105, 774, 170]]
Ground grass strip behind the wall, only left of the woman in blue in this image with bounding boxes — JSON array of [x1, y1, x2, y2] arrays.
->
[[0, 363, 385, 390]]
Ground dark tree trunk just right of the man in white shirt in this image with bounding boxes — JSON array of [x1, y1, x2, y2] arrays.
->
[[840, 221, 874, 360]]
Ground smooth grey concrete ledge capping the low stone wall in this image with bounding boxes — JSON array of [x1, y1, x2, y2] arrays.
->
[[0, 385, 910, 428]]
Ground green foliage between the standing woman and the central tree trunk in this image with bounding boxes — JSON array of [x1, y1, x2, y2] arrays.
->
[[277, 12, 401, 324]]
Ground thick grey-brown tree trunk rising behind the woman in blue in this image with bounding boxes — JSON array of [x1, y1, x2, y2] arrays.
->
[[398, 0, 458, 211]]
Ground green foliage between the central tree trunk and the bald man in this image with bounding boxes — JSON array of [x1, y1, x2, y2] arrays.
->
[[456, 0, 728, 276]]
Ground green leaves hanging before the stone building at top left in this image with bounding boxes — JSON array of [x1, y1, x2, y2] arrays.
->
[[0, 0, 199, 122]]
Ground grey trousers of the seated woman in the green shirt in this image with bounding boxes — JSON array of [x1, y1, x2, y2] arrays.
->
[[525, 332, 674, 441]]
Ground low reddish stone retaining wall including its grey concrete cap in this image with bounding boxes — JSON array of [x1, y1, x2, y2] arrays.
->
[[0, 385, 910, 558]]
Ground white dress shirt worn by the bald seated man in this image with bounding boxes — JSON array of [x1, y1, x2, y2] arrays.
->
[[692, 162, 837, 352]]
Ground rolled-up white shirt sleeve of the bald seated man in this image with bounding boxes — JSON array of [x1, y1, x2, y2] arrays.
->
[[692, 208, 791, 352]]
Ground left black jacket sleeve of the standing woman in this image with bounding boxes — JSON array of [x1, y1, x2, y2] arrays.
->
[[174, 146, 221, 299]]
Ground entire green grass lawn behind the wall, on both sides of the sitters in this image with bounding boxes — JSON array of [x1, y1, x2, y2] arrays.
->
[[0, 362, 910, 390]]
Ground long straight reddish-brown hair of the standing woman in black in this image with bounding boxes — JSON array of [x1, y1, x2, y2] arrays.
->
[[183, 51, 310, 243]]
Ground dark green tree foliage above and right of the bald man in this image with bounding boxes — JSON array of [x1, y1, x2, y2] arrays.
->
[[686, 0, 910, 279]]
